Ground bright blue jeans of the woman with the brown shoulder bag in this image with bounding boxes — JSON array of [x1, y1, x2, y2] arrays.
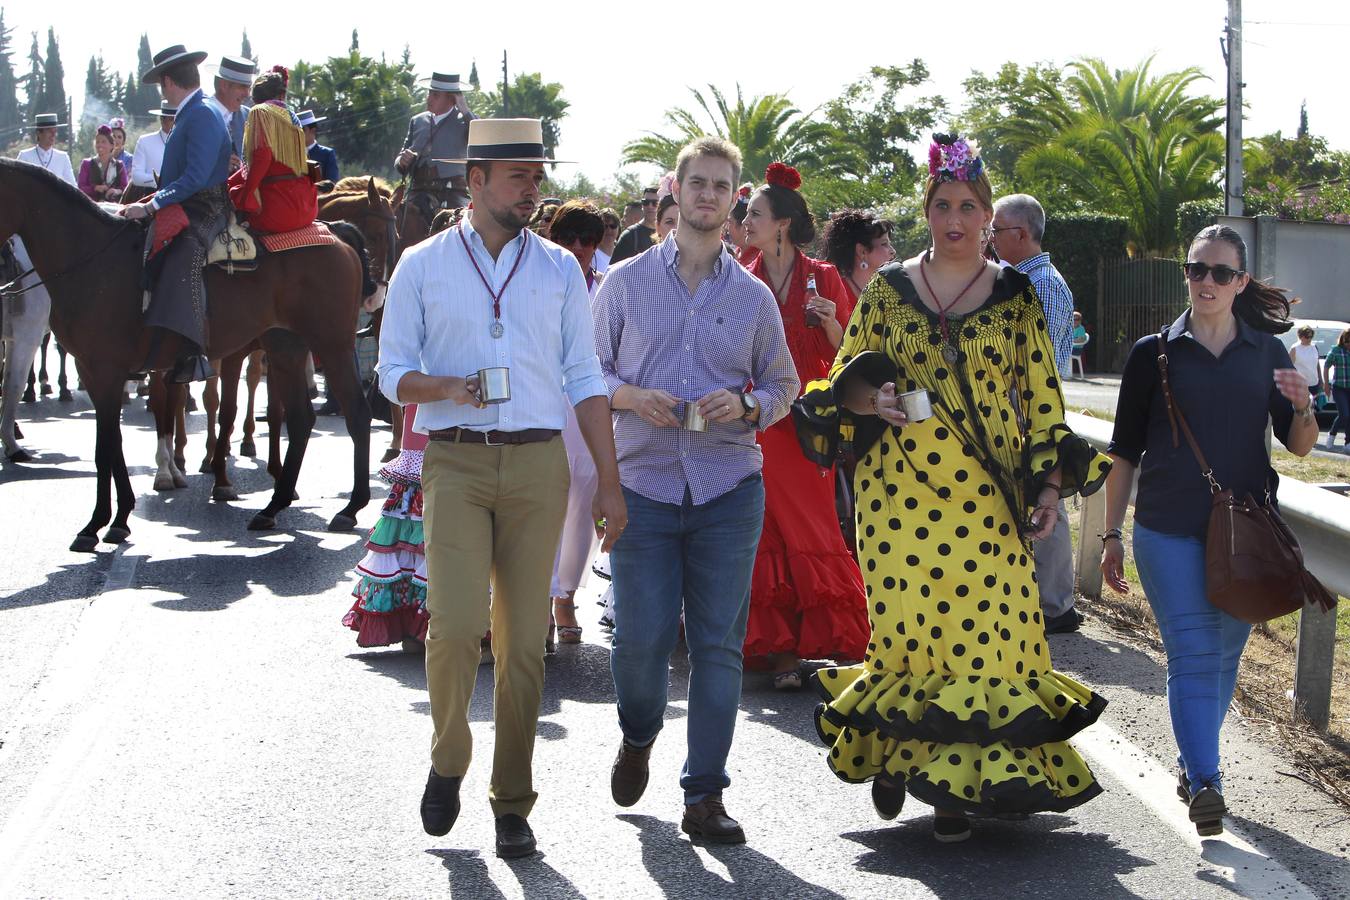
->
[[1134, 522, 1251, 795]]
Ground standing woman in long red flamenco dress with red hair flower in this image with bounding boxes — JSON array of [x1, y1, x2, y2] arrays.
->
[[745, 163, 871, 691]]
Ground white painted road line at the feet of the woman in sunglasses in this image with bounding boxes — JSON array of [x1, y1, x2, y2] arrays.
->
[[1073, 722, 1316, 900]]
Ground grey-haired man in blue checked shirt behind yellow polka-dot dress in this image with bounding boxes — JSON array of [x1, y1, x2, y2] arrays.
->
[[991, 194, 1083, 634]]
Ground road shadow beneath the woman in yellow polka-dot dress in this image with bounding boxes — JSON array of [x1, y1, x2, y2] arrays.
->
[[840, 814, 1157, 900]]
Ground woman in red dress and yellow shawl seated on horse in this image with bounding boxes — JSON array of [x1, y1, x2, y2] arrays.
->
[[228, 66, 319, 233]]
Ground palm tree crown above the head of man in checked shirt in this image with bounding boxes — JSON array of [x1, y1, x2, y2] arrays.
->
[[624, 85, 834, 178]]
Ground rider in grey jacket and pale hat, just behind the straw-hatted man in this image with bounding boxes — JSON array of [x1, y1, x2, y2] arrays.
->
[[394, 72, 474, 217]]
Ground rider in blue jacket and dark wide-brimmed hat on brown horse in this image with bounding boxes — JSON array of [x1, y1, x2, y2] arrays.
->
[[122, 45, 231, 383]]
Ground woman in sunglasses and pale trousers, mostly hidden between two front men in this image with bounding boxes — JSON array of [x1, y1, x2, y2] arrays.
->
[[548, 200, 605, 646]]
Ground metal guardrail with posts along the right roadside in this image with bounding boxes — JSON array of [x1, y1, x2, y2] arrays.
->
[[1067, 413, 1350, 731]]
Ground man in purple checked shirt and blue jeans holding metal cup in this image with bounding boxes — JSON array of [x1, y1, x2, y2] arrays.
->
[[591, 138, 799, 843]]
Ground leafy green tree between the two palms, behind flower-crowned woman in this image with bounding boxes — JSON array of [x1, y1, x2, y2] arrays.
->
[[803, 59, 946, 208]]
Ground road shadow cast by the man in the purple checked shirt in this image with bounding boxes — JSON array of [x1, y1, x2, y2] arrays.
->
[[616, 814, 844, 900]]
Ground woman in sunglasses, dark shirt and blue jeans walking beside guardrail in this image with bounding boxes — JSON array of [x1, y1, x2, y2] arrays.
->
[[1102, 225, 1318, 835]]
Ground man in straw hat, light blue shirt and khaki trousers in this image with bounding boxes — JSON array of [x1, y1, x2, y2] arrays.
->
[[377, 119, 628, 857]]
